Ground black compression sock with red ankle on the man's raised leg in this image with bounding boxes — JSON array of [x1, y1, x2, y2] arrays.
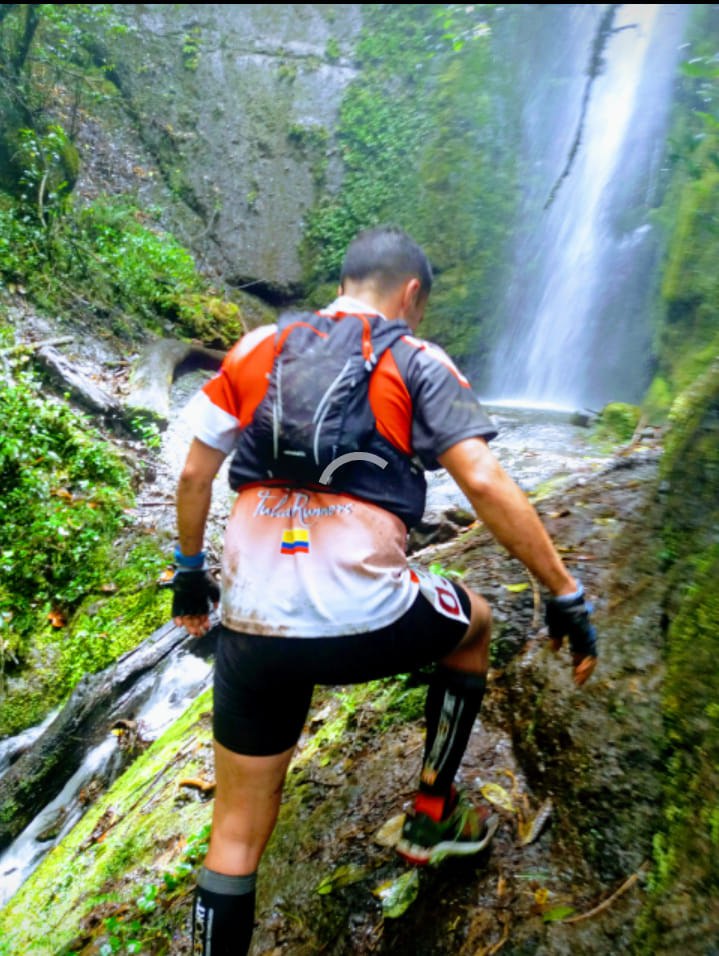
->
[[415, 665, 487, 820]]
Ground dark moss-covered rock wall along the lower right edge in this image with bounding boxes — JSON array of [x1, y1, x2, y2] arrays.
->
[[637, 374, 719, 953]]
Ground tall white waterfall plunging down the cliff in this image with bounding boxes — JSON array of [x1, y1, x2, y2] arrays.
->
[[486, 4, 687, 408]]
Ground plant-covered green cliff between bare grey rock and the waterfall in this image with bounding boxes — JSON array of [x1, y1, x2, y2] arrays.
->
[[303, 4, 517, 370]]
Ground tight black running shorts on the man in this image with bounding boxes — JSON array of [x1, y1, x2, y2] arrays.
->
[[213, 582, 470, 757]]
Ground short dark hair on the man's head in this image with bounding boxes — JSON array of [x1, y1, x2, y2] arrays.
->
[[340, 226, 432, 295]]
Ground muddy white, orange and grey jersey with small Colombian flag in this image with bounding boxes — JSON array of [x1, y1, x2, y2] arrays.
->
[[183, 296, 496, 637]]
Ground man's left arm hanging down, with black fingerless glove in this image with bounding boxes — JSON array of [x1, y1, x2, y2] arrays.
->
[[172, 438, 225, 637]]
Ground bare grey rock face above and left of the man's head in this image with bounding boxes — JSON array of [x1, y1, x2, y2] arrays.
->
[[94, 4, 361, 291]]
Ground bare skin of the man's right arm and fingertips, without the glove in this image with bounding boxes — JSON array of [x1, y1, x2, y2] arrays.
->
[[438, 438, 596, 684]]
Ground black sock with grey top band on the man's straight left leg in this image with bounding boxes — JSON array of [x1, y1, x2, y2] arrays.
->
[[192, 866, 257, 956]]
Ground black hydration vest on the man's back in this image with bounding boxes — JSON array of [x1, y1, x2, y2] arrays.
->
[[230, 312, 426, 527]]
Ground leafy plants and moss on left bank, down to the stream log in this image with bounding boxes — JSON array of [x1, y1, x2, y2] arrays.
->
[[0, 344, 169, 733]]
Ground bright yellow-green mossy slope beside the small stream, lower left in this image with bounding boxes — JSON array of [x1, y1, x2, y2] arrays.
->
[[0, 692, 211, 956]]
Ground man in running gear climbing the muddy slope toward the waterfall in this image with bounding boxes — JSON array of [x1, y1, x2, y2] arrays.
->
[[173, 227, 596, 956]]
